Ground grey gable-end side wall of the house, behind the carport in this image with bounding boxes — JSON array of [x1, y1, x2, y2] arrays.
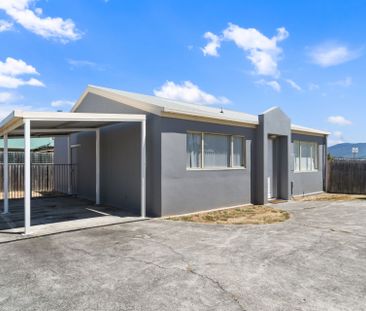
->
[[69, 94, 161, 216]]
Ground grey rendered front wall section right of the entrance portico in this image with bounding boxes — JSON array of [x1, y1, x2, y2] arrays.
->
[[291, 134, 326, 195]]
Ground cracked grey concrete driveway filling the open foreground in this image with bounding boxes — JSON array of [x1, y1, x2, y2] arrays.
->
[[0, 201, 366, 311]]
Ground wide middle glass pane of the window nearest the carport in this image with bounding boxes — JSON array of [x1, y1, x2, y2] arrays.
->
[[204, 134, 230, 167]]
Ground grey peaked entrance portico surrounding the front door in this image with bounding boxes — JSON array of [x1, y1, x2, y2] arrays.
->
[[253, 108, 291, 204]]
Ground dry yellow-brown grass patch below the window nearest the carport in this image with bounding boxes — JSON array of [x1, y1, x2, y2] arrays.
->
[[168, 205, 290, 225]]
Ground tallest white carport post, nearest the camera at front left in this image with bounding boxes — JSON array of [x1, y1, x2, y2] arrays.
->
[[24, 119, 32, 234]]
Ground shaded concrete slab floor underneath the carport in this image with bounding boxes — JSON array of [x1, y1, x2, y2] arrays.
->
[[0, 196, 139, 243]]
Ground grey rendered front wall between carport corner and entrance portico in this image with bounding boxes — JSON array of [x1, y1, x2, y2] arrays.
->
[[161, 118, 255, 215]]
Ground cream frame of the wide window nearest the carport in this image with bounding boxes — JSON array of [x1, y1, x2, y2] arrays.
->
[[186, 131, 247, 171]]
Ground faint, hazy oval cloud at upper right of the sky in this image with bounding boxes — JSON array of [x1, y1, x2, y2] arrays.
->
[[309, 43, 361, 67]]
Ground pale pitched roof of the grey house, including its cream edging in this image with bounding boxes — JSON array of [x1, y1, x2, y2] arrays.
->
[[71, 85, 330, 136]]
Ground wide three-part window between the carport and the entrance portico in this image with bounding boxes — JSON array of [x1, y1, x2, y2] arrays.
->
[[187, 133, 245, 169]]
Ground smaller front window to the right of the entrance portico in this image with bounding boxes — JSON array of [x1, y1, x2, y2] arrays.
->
[[294, 141, 318, 172]]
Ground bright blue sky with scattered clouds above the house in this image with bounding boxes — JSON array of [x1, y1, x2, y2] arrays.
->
[[0, 0, 366, 144]]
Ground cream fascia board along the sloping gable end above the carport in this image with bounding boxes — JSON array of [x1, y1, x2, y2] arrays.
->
[[71, 85, 163, 115]]
